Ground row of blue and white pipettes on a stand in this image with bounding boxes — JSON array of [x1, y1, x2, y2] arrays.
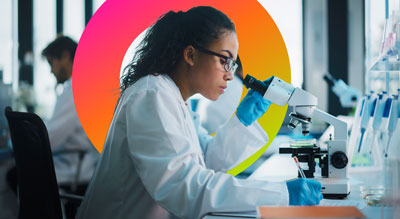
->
[[349, 91, 400, 169]]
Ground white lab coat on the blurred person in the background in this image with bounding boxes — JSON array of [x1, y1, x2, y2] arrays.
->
[[45, 78, 99, 184]]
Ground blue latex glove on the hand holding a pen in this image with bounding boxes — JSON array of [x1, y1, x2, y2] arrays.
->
[[286, 178, 322, 205]]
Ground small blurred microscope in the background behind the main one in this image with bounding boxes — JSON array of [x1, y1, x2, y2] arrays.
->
[[324, 73, 361, 107]]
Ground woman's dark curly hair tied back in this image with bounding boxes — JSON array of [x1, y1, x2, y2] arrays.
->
[[120, 6, 236, 92]]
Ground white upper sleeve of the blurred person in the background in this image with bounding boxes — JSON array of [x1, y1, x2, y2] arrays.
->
[[45, 87, 79, 149]]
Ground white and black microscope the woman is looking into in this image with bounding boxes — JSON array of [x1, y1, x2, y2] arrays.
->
[[243, 75, 350, 198]]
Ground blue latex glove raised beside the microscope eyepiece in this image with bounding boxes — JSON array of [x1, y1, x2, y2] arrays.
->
[[236, 90, 271, 126]]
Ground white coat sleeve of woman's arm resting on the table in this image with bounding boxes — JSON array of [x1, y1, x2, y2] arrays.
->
[[126, 90, 288, 218]]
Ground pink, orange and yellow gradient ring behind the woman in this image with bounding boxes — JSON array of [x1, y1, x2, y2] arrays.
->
[[72, 0, 290, 175]]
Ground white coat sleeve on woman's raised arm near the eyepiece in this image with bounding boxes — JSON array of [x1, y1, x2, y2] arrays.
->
[[204, 114, 268, 172]]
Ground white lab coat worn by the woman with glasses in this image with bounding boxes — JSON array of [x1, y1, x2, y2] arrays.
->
[[77, 75, 288, 219]]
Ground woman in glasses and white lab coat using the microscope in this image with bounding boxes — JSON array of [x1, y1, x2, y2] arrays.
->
[[78, 7, 321, 218]]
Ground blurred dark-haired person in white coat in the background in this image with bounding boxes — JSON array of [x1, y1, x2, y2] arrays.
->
[[42, 36, 99, 190]]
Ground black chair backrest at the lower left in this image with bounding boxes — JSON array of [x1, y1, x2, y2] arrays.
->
[[5, 107, 62, 218]]
